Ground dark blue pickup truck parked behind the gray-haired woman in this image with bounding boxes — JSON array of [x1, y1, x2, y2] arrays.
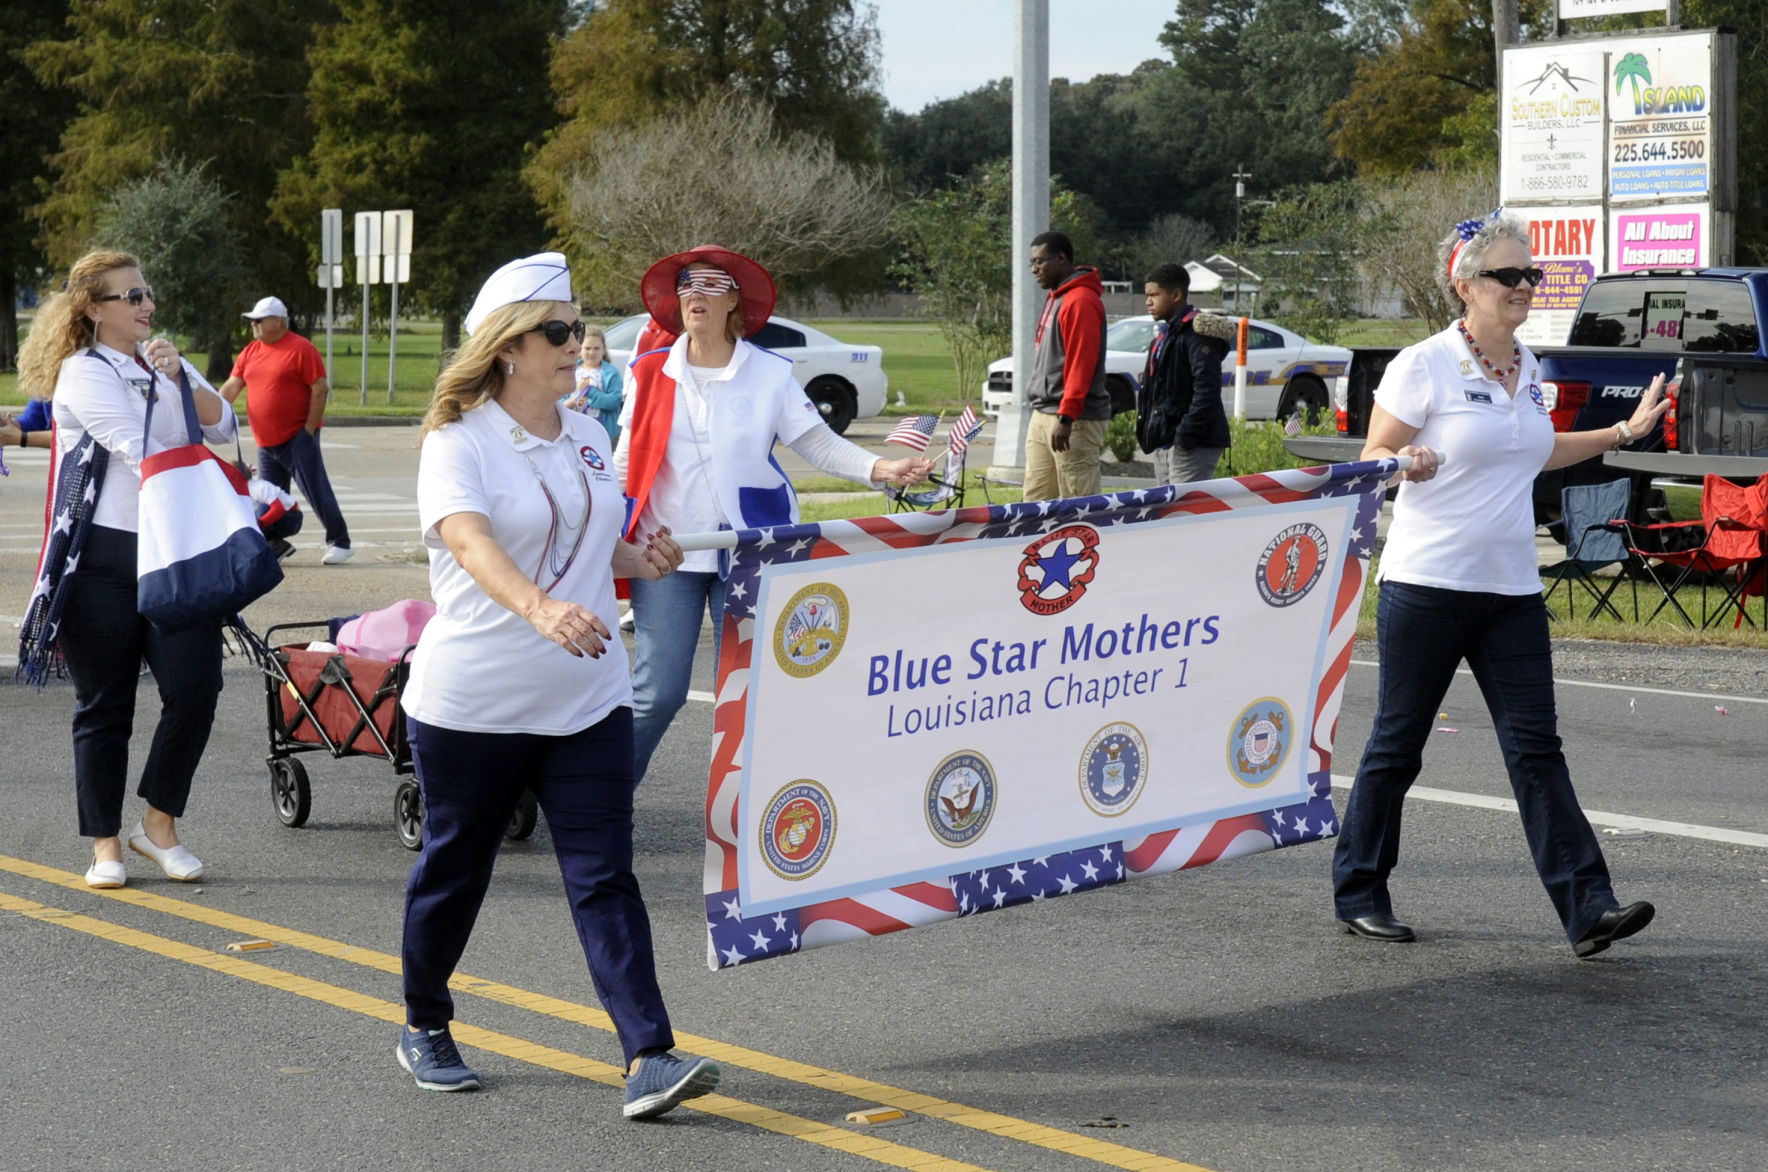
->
[[1287, 269, 1768, 536]]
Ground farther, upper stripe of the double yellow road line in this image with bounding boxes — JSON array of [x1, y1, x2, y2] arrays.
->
[[0, 856, 1209, 1172]]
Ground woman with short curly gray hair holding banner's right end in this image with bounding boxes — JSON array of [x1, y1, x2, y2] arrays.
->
[[1333, 209, 1667, 956]]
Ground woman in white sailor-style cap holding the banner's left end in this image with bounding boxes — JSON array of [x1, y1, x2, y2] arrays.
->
[[398, 253, 718, 1117]]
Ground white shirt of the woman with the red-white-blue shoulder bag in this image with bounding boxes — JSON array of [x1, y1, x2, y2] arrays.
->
[[50, 343, 239, 534]]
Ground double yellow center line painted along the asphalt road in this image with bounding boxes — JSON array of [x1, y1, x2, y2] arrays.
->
[[0, 856, 1208, 1172]]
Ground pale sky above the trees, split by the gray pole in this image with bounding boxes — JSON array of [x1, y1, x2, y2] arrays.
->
[[875, 0, 1179, 113]]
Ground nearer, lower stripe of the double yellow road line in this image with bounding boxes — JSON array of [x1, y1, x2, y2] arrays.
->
[[0, 890, 987, 1172]]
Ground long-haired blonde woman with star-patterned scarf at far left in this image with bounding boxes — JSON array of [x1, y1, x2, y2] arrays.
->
[[18, 251, 239, 887]]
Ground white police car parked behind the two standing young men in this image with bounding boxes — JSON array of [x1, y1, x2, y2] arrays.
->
[[983, 309, 1351, 421]]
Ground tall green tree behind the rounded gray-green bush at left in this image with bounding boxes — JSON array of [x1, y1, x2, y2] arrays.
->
[[23, 0, 331, 318]]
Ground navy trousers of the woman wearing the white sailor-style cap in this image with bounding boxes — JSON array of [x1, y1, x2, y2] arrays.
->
[[403, 707, 675, 1064]]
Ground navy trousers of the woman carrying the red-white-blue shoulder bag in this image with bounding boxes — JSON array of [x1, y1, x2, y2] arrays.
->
[[57, 525, 221, 838]]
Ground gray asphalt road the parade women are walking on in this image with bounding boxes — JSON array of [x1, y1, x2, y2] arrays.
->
[[0, 428, 1768, 1172]]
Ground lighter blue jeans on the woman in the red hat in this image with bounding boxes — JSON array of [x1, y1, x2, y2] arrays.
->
[[631, 569, 725, 781]]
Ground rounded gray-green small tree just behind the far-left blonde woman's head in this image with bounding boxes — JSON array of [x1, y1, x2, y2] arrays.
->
[[94, 159, 248, 384]]
